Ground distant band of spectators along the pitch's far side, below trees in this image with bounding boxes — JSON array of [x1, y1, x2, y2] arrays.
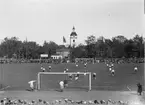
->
[[0, 58, 145, 64]]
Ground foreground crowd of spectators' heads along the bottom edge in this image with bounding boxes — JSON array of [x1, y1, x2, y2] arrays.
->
[[0, 98, 134, 105]]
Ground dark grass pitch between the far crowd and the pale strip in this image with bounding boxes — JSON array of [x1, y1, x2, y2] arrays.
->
[[0, 63, 144, 91]]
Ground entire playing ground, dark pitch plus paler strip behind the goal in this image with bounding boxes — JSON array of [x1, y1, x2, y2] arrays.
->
[[0, 63, 145, 105]]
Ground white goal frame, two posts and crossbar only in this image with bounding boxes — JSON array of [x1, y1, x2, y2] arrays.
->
[[37, 72, 92, 91]]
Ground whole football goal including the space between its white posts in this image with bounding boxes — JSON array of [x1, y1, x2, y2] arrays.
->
[[37, 72, 91, 91]]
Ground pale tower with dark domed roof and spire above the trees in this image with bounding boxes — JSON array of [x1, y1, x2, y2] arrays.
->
[[70, 27, 77, 47]]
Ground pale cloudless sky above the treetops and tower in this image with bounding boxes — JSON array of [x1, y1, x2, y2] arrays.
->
[[0, 0, 145, 45]]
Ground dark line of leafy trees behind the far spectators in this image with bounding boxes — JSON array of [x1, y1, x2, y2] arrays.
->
[[0, 35, 144, 59]]
